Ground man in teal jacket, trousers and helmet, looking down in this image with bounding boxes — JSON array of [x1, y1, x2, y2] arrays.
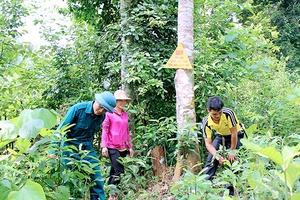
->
[[52, 92, 116, 200]]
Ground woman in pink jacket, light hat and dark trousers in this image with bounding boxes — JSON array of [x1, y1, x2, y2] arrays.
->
[[101, 90, 133, 200]]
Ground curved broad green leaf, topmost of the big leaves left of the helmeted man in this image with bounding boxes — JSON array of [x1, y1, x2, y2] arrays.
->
[[31, 108, 57, 129]]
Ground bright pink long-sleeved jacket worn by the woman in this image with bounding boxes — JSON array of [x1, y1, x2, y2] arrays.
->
[[101, 110, 132, 150]]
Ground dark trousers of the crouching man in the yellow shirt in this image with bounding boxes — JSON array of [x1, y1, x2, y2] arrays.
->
[[203, 134, 242, 180]]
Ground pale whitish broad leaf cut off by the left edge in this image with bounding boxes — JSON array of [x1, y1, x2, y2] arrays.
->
[[0, 121, 19, 141]]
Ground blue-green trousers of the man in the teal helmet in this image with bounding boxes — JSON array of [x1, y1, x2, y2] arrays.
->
[[63, 140, 105, 200]]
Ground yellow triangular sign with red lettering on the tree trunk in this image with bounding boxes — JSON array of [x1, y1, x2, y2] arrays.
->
[[165, 43, 192, 69]]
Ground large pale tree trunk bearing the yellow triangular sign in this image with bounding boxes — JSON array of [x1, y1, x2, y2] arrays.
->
[[173, 0, 200, 181]]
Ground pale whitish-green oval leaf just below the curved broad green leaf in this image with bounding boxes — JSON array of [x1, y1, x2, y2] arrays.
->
[[19, 119, 44, 139]]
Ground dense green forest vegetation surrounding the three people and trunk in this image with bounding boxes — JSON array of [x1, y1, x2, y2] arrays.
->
[[0, 0, 300, 199]]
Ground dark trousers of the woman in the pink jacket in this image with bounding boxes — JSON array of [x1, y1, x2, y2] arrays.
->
[[108, 148, 128, 185]]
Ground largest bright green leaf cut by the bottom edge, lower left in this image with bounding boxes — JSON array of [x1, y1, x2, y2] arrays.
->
[[7, 180, 46, 200]]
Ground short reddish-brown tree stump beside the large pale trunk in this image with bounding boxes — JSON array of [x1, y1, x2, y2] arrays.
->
[[151, 146, 165, 177]]
